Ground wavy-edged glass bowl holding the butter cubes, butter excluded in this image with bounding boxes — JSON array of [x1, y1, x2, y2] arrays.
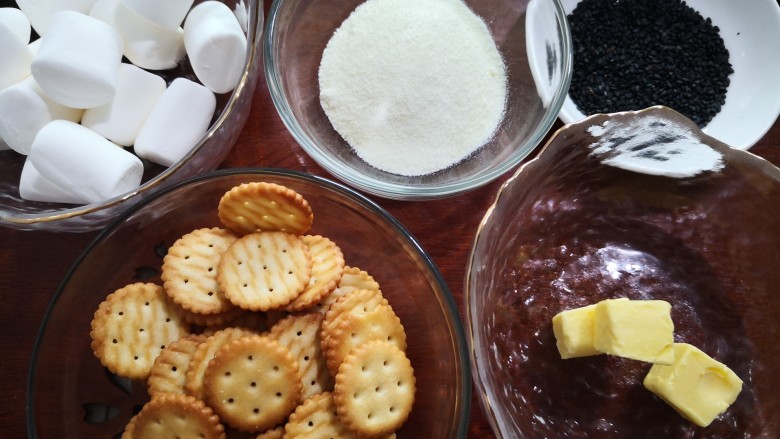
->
[[464, 107, 780, 438]]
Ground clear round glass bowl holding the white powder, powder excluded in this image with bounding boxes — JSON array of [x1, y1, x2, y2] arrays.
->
[[264, 0, 571, 200]]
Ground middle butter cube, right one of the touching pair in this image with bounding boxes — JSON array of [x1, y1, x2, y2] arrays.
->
[[593, 299, 674, 365]]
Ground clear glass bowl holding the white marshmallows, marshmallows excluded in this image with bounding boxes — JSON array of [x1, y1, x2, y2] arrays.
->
[[0, 0, 264, 232]]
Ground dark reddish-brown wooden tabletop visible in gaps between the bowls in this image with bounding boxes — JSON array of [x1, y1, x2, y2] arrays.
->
[[0, 60, 780, 438]]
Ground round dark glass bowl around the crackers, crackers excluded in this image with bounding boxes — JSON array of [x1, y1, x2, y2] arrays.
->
[[27, 169, 472, 438]]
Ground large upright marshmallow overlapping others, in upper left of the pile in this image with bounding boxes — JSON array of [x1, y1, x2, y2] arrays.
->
[[31, 11, 122, 108]]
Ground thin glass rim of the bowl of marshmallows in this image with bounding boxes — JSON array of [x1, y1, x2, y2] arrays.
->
[[0, 0, 264, 227]]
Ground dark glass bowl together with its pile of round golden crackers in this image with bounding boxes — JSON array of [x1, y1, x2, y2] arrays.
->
[[27, 168, 471, 438]]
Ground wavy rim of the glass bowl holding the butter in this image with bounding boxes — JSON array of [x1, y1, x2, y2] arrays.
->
[[463, 105, 780, 437]]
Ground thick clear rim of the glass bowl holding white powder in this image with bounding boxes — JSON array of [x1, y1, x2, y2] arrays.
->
[[263, 0, 573, 200]]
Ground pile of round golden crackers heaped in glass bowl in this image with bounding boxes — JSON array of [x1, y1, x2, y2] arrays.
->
[[90, 182, 416, 439]]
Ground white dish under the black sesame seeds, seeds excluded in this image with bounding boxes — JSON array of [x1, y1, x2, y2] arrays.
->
[[552, 0, 780, 149]]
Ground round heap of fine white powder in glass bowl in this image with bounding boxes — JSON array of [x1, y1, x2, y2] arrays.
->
[[319, 0, 507, 176]]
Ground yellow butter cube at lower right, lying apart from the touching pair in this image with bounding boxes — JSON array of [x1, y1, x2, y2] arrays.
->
[[644, 343, 742, 427]]
